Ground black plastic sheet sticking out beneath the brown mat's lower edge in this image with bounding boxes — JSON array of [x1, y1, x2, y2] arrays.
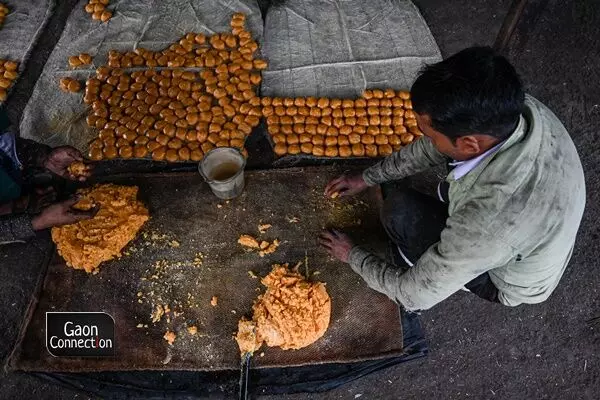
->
[[32, 310, 428, 398]]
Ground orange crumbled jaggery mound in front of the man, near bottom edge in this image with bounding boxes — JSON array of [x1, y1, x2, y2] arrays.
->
[[236, 264, 331, 354]]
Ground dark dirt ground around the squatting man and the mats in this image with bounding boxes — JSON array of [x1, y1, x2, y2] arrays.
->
[[0, 0, 600, 399]]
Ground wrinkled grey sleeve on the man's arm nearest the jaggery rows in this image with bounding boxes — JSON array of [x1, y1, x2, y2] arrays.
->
[[363, 136, 446, 186]]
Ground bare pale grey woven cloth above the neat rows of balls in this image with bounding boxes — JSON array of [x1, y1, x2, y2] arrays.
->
[[261, 0, 441, 98]]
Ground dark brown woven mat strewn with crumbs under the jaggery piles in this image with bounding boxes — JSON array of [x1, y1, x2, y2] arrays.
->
[[9, 168, 402, 372]]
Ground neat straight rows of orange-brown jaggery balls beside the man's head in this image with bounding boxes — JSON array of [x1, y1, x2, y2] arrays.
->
[[262, 89, 423, 157]]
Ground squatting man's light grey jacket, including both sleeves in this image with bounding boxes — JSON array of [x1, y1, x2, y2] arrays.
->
[[349, 96, 585, 310]]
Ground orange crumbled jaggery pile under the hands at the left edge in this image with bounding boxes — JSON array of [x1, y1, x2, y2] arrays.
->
[[52, 184, 148, 273]]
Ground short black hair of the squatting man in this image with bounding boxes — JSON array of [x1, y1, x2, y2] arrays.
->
[[411, 47, 525, 141]]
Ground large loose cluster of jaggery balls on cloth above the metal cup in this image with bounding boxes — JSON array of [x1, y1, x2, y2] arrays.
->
[[67, 14, 266, 162]]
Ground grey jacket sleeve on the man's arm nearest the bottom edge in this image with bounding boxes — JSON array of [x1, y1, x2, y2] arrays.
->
[[348, 198, 516, 310]]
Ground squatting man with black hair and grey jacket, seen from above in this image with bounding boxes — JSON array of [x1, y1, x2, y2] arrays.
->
[[319, 47, 585, 310]]
